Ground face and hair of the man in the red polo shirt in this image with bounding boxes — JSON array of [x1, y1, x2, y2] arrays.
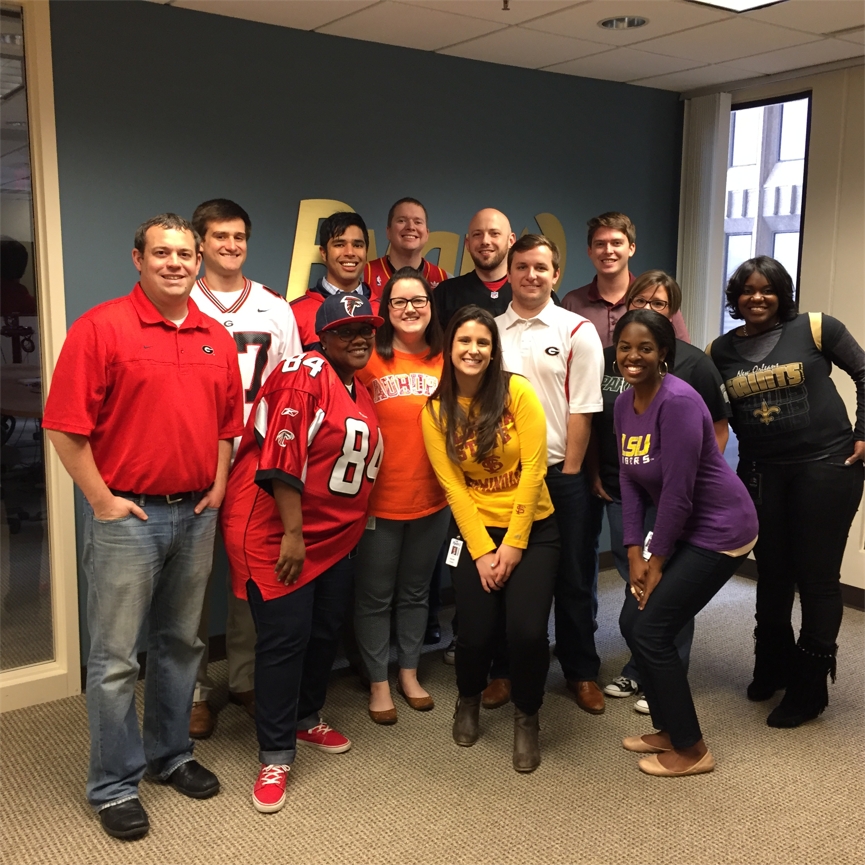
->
[[132, 225, 201, 315]]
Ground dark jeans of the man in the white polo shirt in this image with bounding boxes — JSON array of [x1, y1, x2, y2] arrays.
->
[[547, 463, 601, 681]]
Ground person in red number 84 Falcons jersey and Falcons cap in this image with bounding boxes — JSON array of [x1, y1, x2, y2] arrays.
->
[[221, 292, 383, 813]]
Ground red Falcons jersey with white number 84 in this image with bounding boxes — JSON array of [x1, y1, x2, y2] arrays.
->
[[221, 351, 383, 600]]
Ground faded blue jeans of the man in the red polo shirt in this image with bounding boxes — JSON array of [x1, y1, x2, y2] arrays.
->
[[82, 497, 217, 811]]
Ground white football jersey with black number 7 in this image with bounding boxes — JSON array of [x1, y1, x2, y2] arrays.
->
[[191, 279, 303, 426]]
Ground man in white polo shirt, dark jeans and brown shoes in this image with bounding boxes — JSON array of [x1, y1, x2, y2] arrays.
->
[[496, 234, 604, 715]]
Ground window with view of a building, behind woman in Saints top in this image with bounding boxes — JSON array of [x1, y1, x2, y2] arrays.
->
[[721, 96, 811, 333]]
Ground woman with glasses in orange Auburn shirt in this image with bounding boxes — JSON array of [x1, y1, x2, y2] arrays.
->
[[354, 267, 449, 724]]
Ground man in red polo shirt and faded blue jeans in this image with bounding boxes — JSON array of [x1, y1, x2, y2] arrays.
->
[[43, 213, 243, 839]]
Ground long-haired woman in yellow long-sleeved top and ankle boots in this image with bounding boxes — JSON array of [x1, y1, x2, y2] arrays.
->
[[421, 306, 559, 772]]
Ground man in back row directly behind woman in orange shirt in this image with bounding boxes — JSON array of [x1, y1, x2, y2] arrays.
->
[[363, 198, 450, 309]]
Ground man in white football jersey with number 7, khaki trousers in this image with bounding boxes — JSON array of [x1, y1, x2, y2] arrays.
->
[[189, 198, 301, 739]]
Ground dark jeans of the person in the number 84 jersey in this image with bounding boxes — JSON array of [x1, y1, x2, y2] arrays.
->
[[246, 556, 355, 764]]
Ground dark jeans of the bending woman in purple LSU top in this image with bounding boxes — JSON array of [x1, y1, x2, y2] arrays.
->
[[619, 543, 745, 748]]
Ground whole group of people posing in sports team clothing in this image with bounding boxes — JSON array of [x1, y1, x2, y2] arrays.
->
[[44, 198, 865, 839]]
